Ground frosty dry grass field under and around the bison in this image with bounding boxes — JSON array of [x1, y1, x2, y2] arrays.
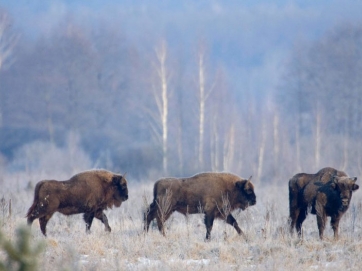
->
[[0, 178, 362, 271]]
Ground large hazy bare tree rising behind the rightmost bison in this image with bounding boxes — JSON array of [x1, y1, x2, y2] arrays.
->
[[283, 24, 362, 175]]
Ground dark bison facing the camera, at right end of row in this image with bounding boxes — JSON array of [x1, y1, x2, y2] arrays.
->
[[289, 167, 359, 239]]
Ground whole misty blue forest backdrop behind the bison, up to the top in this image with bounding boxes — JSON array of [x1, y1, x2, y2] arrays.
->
[[0, 0, 362, 187]]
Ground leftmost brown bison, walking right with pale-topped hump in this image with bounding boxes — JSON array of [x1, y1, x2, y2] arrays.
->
[[26, 170, 128, 236]]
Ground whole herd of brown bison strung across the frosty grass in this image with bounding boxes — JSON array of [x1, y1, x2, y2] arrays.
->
[[26, 167, 359, 239]]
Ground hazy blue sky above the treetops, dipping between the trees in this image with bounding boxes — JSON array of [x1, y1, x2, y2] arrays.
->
[[0, 0, 362, 101]]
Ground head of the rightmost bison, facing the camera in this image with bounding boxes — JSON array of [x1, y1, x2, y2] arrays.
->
[[332, 176, 359, 210]]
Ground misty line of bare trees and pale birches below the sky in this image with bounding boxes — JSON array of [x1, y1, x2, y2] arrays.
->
[[0, 11, 362, 181]]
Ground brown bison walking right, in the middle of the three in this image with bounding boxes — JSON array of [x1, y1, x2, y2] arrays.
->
[[145, 173, 256, 239]]
